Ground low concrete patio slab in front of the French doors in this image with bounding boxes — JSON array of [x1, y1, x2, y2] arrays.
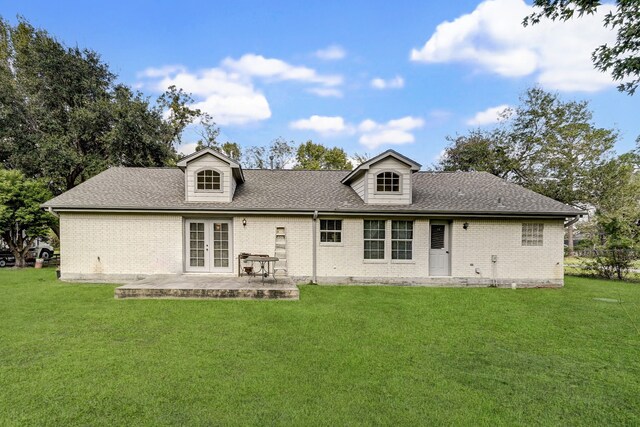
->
[[115, 274, 300, 300]]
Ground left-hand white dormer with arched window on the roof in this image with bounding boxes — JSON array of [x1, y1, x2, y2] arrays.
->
[[178, 148, 244, 203]]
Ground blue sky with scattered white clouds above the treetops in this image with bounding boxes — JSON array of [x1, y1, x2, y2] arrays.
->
[[0, 0, 640, 166]]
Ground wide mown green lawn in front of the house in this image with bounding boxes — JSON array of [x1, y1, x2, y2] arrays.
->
[[0, 269, 640, 426]]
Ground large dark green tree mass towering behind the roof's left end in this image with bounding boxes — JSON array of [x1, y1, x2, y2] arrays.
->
[[0, 19, 199, 194]]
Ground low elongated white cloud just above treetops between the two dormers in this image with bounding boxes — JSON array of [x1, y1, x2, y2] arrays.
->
[[289, 115, 425, 150]]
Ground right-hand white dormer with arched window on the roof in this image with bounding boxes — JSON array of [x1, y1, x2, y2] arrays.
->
[[342, 150, 421, 205]]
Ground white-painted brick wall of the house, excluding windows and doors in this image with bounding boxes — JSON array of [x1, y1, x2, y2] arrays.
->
[[60, 213, 564, 284]]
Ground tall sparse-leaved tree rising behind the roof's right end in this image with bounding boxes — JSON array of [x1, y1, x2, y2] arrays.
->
[[503, 88, 618, 208]]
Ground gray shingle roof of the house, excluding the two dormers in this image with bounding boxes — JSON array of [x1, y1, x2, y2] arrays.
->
[[43, 167, 581, 216]]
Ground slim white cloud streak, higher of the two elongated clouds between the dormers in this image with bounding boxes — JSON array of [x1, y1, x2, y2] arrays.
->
[[222, 53, 342, 86]]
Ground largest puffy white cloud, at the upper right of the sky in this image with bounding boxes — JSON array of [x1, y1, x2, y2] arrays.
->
[[411, 0, 615, 92]]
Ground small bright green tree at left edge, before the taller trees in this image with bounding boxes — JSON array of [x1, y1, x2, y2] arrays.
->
[[0, 169, 55, 267]]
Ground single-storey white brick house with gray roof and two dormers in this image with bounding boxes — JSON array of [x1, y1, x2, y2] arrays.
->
[[43, 149, 582, 286]]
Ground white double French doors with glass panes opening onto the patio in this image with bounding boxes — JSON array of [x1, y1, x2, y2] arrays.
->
[[185, 219, 233, 273]]
